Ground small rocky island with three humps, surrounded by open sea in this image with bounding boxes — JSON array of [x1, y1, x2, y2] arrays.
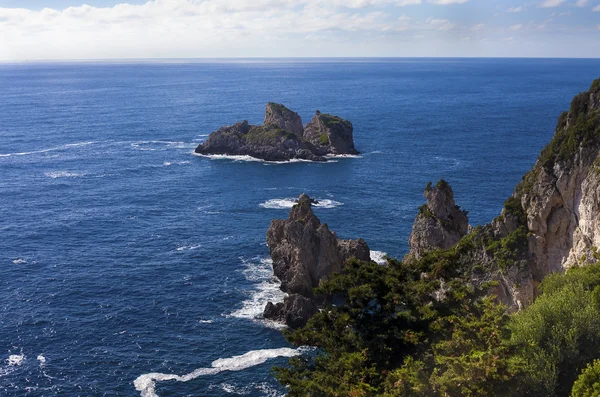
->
[[195, 102, 359, 161]]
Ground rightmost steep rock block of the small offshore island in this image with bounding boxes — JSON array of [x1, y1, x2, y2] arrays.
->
[[304, 110, 358, 154]]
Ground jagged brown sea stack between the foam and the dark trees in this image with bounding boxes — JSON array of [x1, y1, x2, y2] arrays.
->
[[264, 194, 370, 328]]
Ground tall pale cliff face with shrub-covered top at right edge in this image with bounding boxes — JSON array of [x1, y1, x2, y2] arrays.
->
[[515, 80, 600, 279]]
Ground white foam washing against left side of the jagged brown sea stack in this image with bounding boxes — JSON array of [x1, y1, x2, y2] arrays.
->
[[230, 258, 286, 328]]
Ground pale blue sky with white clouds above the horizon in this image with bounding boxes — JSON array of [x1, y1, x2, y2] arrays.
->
[[0, 0, 600, 61]]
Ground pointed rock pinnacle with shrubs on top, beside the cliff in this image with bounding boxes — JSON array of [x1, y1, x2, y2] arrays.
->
[[409, 180, 469, 259]]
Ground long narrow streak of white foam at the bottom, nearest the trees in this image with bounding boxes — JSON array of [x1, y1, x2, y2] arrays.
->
[[133, 347, 301, 397]]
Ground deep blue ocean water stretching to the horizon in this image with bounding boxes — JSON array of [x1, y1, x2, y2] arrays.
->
[[0, 59, 600, 397]]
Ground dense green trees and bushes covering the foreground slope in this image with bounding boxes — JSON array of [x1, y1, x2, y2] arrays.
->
[[275, 255, 600, 397]]
